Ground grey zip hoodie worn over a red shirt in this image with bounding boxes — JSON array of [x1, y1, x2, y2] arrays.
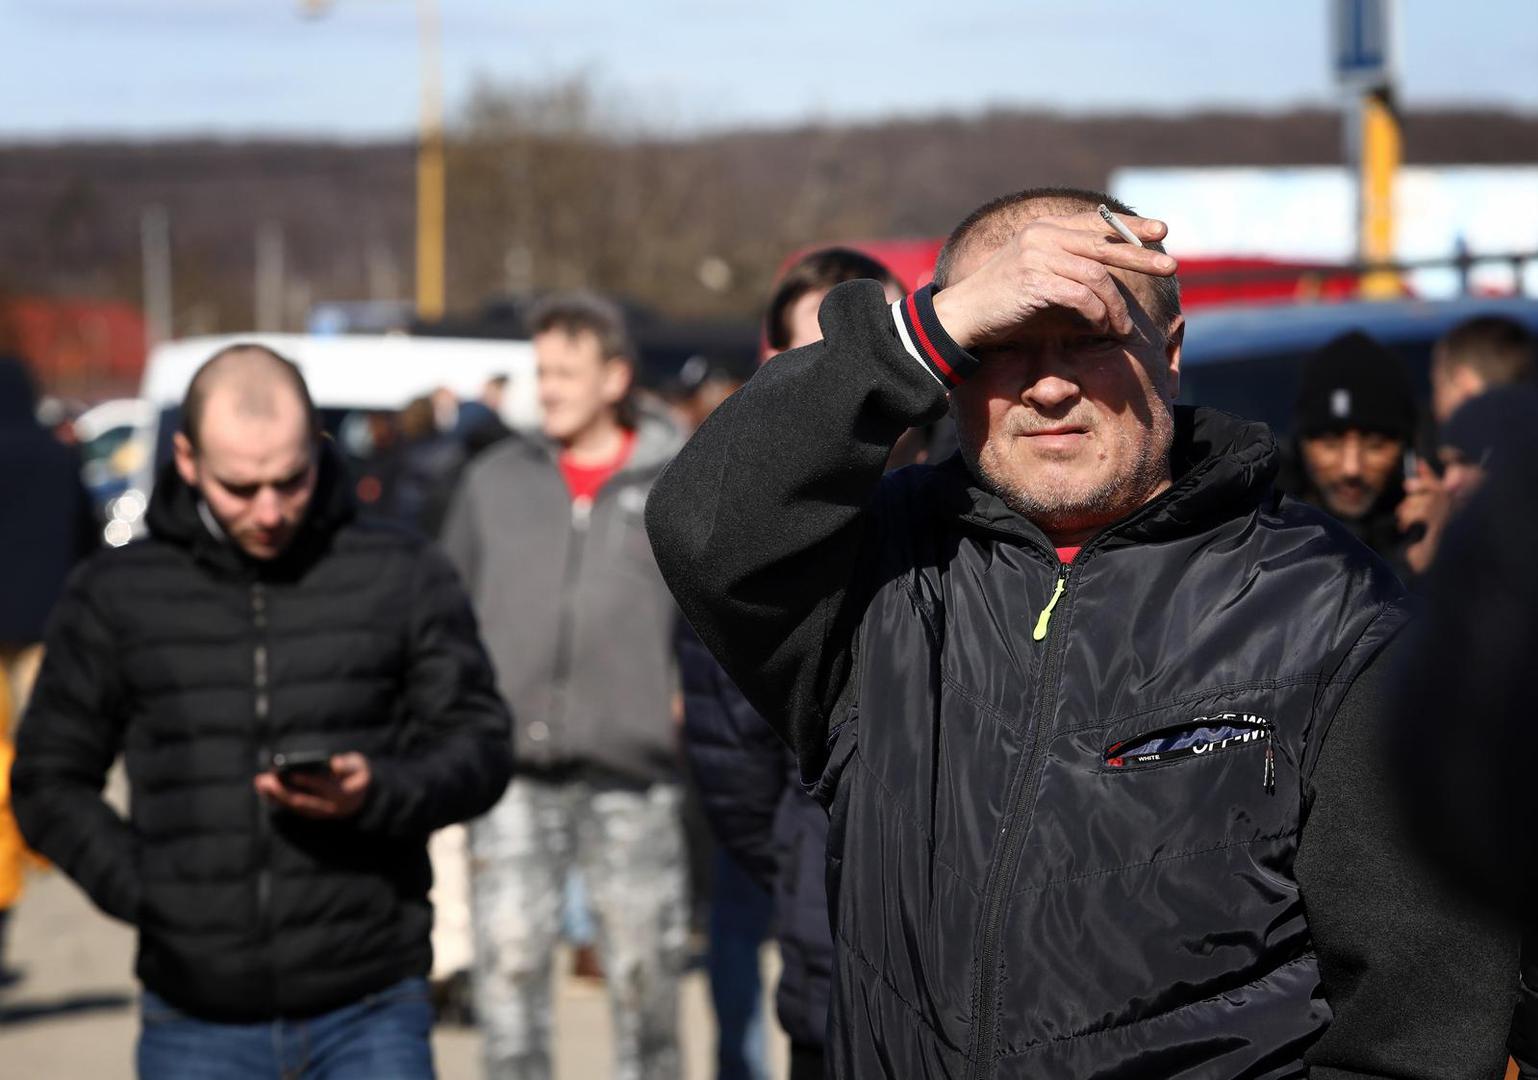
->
[[441, 414, 681, 783]]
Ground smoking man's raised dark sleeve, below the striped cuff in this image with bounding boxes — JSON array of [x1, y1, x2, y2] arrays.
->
[[646, 282, 947, 778]]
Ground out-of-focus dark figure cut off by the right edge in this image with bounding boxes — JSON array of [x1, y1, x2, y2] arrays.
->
[[1393, 381, 1538, 1080]]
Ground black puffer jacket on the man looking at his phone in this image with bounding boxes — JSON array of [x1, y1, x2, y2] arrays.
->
[[12, 443, 512, 1020]]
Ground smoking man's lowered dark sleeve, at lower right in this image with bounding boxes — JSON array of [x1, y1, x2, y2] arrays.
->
[[1297, 635, 1518, 1080]]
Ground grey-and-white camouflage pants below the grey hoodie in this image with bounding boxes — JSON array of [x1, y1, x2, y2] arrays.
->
[[471, 777, 687, 1080]]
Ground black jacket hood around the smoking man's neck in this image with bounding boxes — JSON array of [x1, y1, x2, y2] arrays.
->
[[935, 405, 1278, 551]]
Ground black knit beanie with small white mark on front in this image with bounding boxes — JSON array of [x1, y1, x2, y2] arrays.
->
[[1293, 331, 1415, 442]]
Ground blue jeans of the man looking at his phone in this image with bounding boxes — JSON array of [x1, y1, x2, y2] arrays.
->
[[138, 978, 434, 1080]]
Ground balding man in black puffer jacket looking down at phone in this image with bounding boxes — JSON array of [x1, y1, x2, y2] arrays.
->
[[14, 346, 512, 1080]]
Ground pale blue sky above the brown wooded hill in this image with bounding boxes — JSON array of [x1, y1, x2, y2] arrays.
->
[[0, 0, 1538, 140]]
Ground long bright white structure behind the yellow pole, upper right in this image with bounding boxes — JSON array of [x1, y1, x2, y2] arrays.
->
[[1110, 165, 1538, 298]]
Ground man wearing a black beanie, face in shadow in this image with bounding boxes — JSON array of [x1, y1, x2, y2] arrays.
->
[[1289, 331, 1415, 577]]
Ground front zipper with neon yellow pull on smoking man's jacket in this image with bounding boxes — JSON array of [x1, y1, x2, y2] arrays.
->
[[969, 563, 1072, 1080]]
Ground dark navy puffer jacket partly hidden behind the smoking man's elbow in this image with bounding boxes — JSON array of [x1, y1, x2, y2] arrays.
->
[[678, 626, 834, 1046]]
